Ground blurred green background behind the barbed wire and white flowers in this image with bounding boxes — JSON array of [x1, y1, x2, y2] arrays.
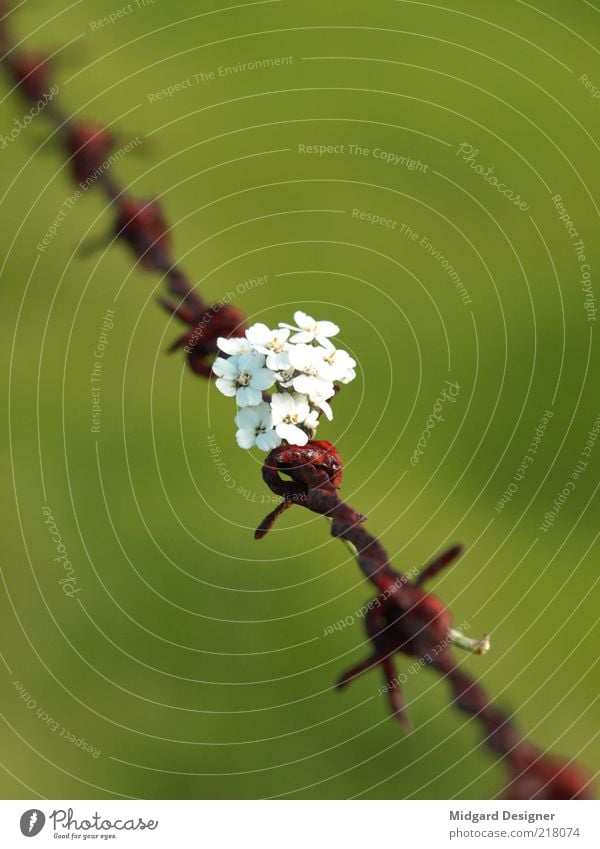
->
[[0, 0, 600, 799]]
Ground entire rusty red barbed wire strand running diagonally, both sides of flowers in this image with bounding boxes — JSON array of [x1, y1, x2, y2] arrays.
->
[[0, 6, 592, 799]]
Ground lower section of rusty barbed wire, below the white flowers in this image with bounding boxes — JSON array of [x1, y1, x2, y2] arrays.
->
[[256, 442, 592, 800]]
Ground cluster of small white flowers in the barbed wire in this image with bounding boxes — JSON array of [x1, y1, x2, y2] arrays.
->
[[213, 311, 356, 451]]
